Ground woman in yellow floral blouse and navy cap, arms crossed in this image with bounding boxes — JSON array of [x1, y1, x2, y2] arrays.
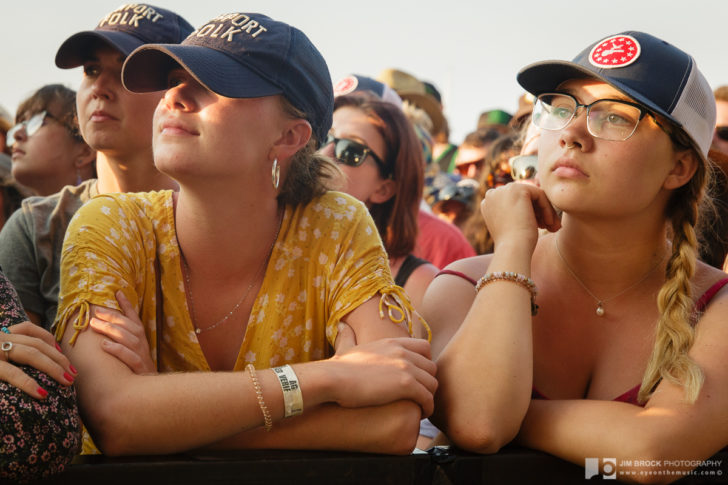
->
[[57, 13, 437, 455]]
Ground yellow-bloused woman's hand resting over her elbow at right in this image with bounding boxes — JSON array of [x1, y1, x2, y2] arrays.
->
[[326, 323, 437, 418]]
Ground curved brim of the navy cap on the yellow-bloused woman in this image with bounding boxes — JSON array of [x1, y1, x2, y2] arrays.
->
[[121, 44, 283, 98]]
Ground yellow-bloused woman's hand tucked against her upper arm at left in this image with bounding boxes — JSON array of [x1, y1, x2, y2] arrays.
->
[[89, 291, 157, 375]]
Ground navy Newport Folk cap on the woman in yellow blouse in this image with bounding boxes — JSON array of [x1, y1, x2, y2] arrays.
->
[[122, 13, 334, 144]]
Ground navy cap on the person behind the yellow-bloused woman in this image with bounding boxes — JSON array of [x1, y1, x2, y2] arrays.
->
[[56, 3, 194, 69]]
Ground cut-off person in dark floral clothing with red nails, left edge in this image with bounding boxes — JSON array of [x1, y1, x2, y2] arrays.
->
[[0, 271, 81, 483]]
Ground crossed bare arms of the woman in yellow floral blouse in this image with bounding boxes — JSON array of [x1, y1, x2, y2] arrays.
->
[[63, 294, 436, 455]]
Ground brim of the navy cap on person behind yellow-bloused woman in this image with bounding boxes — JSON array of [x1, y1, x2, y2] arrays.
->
[[56, 30, 144, 69]]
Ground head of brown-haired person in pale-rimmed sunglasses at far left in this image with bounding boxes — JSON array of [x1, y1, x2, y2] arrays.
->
[[6, 84, 96, 196]]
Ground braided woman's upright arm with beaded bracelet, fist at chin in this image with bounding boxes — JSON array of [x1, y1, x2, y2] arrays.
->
[[425, 184, 560, 453]]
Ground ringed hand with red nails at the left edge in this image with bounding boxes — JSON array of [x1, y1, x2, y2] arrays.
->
[[0, 322, 78, 399]]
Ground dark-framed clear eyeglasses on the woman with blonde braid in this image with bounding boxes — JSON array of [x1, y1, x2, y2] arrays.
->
[[533, 93, 661, 141]]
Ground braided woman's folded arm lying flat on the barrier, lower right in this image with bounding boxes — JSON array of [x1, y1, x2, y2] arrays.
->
[[518, 296, 728, 479]]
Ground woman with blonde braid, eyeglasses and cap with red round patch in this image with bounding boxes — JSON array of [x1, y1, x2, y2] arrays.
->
[[424, 31, 728, 481]]
